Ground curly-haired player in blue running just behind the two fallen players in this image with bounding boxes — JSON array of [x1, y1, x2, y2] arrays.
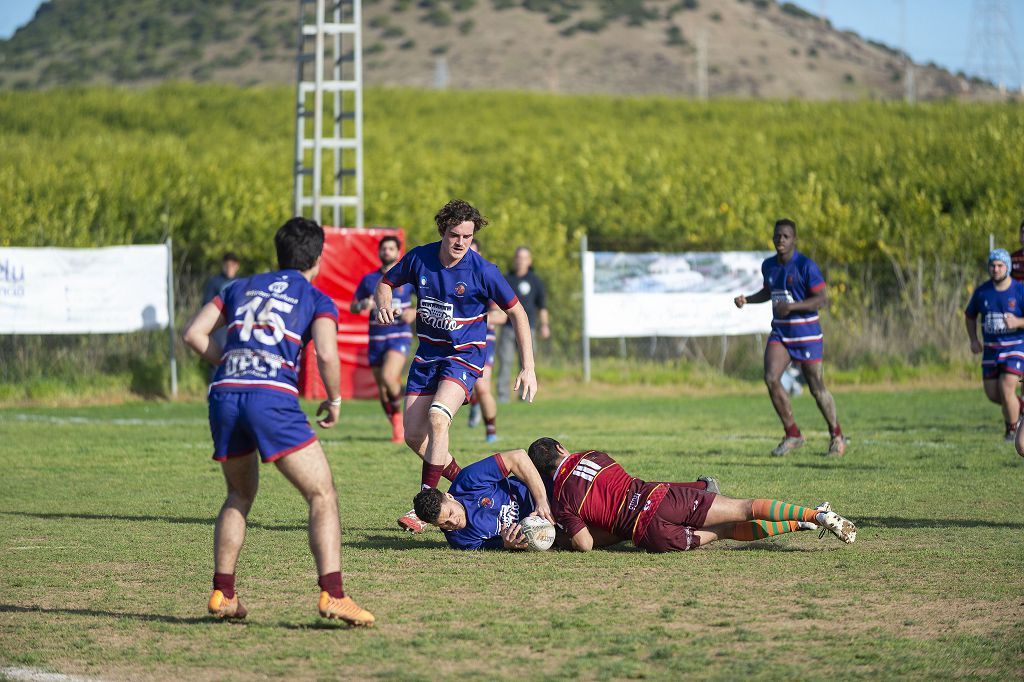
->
[[374, 200, 537, 532]]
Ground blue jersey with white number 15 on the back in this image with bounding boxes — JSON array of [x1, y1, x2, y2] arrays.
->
[[210, 270, 338, 395]]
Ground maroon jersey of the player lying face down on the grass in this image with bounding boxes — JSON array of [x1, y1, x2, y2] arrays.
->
[[552, 450, 669, 544]]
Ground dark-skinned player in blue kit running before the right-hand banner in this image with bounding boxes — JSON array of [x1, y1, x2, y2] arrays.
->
[[734, 218, 847, 457]]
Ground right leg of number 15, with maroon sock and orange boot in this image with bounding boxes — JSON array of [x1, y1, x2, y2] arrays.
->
[[274, 440, 374, 626]]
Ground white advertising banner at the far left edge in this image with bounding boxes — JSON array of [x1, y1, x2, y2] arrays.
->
[[0, 244, 170, 334]]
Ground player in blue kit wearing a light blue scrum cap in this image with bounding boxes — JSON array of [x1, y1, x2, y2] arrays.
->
[[964, 249, 1024, 440]]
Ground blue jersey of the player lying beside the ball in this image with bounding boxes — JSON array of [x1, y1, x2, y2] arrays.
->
[[444, 455, 534, 549]]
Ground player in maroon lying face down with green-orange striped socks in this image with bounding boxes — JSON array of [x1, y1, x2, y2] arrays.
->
[[529, 438, 857, 552]]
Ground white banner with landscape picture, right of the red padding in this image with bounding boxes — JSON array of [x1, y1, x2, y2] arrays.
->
[[583, 251, 773, 338]]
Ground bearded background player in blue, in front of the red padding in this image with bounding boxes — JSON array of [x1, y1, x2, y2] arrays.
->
[[349, 236, 416, 442]]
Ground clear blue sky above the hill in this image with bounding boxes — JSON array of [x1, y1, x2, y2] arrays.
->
[[0, 0, 1024, 87]]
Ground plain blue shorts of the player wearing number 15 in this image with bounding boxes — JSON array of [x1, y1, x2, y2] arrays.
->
[[210, 391, 316, 462]]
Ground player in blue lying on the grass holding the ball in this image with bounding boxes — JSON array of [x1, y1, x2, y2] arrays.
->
[[413, 450, 718, 550]]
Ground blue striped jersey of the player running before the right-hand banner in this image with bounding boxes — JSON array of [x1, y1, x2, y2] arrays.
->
[[761, 251, 825, 343]]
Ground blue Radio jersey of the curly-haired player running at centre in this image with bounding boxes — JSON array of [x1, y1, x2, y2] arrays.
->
[[384, 242, 519, 376]]
